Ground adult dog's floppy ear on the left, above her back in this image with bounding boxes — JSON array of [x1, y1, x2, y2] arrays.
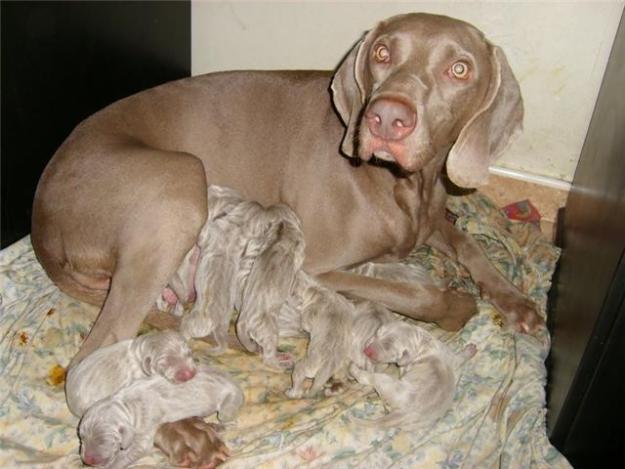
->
[[330, 27, 378, 156]]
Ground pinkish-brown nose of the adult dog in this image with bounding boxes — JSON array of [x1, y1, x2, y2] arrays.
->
[[365, 98, 417, 140]]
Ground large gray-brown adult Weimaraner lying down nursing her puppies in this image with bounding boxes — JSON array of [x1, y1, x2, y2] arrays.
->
[[32, 14, 542, 463]]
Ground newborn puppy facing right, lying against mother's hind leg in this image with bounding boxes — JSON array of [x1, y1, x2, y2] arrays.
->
[[65, 330, 196, 417]]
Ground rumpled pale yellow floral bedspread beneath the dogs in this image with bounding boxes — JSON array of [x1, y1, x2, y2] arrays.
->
[[0, 193, 570, 469]]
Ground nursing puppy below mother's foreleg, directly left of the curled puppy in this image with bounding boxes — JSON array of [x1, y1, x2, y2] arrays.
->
[[286, 272, 394, 399]]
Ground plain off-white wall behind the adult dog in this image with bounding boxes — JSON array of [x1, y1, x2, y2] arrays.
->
[[192, 0, 624, 185]]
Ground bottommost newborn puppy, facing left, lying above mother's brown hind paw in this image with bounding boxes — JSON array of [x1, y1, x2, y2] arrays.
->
[[78, 365, 244, 469]]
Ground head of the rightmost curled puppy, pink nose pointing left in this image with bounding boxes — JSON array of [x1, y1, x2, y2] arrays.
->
[[363, 320, 422, 366]]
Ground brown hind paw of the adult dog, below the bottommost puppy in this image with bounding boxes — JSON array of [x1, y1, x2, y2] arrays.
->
[[154, 417, 230, 469]]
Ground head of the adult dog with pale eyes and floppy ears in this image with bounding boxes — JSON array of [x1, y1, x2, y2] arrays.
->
[[332, 13, 523, 187]]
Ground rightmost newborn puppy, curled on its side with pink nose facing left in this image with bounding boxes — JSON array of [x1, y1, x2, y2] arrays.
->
[[350, 320, 476, 426]]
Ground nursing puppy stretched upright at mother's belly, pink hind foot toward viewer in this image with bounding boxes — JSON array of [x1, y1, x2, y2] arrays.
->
[[236, 204, 304, 369]]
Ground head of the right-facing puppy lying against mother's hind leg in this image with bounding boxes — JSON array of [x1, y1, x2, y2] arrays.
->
[[139, 330, 197, 383]]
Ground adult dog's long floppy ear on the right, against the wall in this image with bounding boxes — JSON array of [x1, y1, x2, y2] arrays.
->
[[447, 43, 523, 187]]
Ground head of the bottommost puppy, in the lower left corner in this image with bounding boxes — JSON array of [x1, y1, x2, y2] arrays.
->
[[78, 399, 135, 466]]
